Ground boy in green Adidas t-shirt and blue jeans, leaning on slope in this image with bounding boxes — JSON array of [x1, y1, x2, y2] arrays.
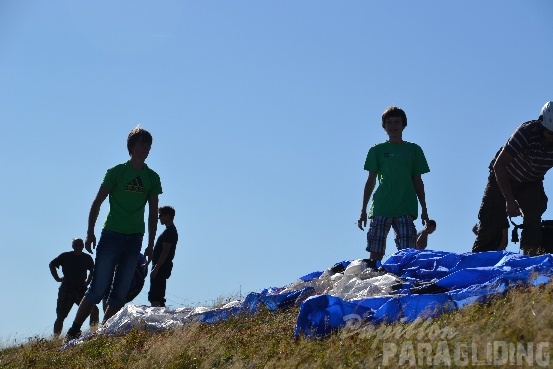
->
[[65, 126, 162, 341]]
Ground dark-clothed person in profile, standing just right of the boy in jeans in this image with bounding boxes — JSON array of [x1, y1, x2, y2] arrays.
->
[[148, 206, 179, 307]]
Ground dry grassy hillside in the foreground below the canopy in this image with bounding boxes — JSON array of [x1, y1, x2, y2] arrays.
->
[[0, 283, 553, 369]]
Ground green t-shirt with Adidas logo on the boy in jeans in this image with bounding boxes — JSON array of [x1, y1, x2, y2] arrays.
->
[[102, 161, 162, 234]]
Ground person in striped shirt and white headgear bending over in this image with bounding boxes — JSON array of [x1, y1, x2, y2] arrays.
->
[[472, 101, 553, 256]]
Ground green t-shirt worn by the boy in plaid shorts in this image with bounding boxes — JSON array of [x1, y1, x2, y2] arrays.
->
[[365, 142, 430, 219]]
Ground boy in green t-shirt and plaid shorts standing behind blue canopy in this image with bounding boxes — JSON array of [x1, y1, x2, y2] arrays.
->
[[357, 106, 430, 268]]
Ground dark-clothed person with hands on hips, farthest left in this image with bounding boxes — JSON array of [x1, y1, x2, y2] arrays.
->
[[49, 238, 99, 337]]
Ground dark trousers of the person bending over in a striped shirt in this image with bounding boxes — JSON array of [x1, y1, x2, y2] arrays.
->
[[472, 171, 547, 252]]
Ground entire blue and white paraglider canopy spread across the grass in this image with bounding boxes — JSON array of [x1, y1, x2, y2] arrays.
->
[[89, 249, 553, 338]]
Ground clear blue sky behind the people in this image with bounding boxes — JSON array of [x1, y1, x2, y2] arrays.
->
[[0, 0, 553, 343]]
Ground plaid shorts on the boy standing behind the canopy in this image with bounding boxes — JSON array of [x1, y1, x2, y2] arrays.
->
[[366, 215, 417, 254]]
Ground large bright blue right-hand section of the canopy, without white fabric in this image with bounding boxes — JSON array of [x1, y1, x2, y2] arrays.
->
[[294, 249, 553, 338]]
